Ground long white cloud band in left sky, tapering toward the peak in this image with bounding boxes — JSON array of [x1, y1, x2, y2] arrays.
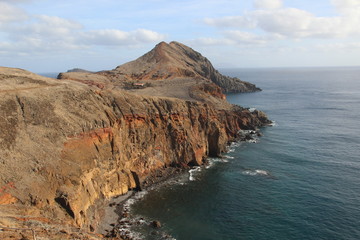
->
[[0, 1, 165, 54]]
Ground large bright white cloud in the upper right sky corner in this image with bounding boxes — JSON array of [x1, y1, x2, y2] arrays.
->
[[204, 0, 360, 44]]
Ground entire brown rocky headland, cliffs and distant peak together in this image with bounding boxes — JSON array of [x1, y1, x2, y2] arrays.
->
[[0, 42, 270, 239]]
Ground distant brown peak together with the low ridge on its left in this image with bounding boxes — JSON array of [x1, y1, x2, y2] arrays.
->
[[59, 42, 261, 96]]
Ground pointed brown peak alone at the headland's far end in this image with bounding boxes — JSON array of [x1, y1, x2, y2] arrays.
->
[[111, 41, 261, 92]]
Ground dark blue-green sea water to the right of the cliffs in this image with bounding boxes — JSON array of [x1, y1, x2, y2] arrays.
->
[[131, 68, 360, 240]]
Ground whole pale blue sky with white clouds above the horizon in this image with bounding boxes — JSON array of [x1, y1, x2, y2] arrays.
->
[[0, 0, 360, 73]]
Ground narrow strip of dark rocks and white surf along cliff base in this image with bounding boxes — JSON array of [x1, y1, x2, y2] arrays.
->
[[102, 127, 273, 240]]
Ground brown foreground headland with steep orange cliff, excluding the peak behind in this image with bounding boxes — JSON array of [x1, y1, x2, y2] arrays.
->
[[0, 46, 268, 239]]
